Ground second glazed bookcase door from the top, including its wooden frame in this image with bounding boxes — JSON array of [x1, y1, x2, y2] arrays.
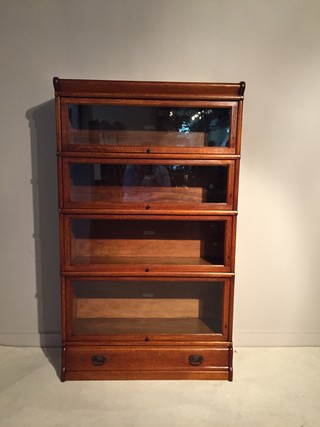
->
[[63, 158, 235, 211]]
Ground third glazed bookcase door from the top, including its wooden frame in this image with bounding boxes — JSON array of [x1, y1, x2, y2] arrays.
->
[[65, 215, 233, 273]]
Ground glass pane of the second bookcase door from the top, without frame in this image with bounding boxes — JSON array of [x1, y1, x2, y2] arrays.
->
[[70, 163, 228, 204]]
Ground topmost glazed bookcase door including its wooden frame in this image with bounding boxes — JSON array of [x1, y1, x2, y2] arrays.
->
[[61, 98, 237, 152]]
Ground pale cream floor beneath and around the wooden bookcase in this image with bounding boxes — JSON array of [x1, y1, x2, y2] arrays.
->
[[0, 347, 320, 427]]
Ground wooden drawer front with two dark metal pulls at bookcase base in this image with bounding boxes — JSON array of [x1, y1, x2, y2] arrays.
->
[[66, 346, 232, 371]]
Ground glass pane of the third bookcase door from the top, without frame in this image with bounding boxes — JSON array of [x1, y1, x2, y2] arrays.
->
[[71, 218, 225, 265]]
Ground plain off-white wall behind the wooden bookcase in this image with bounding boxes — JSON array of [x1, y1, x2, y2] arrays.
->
[[0, 0, 320, 346]]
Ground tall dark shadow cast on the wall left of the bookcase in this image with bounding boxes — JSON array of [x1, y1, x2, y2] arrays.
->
[[26, 100, 61, 382]]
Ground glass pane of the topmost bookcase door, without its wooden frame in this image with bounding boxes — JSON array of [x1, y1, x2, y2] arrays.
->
[[68, 104, 231, 147]]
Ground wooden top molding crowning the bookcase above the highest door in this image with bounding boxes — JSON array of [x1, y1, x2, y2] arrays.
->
[[53, 77, 245, 101]]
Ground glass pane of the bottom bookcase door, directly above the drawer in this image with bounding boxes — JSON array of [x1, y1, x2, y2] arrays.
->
[[72, 280, 224, 335]]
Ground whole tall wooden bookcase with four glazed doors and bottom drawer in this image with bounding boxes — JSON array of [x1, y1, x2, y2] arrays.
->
[[54, 78, 245, 381]]
